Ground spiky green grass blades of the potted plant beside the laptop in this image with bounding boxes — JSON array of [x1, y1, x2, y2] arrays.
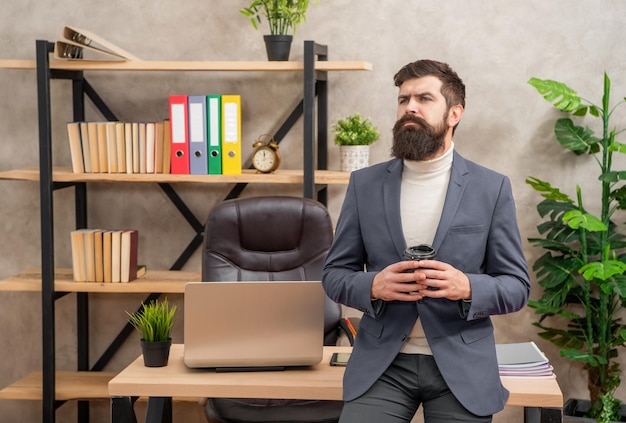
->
[[126, 298, 176, 342]]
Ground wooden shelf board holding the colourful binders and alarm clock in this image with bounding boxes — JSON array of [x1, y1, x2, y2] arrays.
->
[[0, 167, 350, 185]]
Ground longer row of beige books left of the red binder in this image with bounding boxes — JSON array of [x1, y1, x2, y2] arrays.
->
[[67, 120, 170, 173]]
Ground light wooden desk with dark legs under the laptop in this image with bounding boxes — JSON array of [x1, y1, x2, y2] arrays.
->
[[109, 344, 563, 423]]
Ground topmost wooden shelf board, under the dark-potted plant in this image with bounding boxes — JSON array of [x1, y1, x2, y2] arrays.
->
[[0, 59, 372, 72]]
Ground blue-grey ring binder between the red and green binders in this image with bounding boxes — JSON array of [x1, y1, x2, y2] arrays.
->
[[188, 95, 209, 175]]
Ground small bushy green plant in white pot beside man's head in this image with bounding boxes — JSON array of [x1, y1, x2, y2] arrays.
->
[[331, 113, 380, 172]]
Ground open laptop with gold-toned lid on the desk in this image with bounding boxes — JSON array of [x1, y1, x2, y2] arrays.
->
[[184, 281, 324, 371]]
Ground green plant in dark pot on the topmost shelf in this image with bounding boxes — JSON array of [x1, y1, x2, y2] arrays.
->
[[240, 0, 317, 60]]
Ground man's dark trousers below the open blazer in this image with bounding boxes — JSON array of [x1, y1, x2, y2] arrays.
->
[[339, 354, 491, 423]]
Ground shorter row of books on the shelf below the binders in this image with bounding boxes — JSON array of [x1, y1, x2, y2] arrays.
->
[[71, 229, 145, 282]]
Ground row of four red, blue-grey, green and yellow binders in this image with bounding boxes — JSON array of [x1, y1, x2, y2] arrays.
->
[[169, 94, 242, 175]]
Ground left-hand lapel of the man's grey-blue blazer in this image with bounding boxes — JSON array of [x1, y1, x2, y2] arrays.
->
[[383, 159, 406, 258]]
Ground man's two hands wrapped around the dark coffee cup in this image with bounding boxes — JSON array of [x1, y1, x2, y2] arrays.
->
[[372, 260, 472, 301]]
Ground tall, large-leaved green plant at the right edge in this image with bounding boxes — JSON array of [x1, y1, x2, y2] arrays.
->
[[526, 74, 626, 422]]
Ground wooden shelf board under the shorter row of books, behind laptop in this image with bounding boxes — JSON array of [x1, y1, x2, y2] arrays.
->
[[0, 269, 201, 294]]
